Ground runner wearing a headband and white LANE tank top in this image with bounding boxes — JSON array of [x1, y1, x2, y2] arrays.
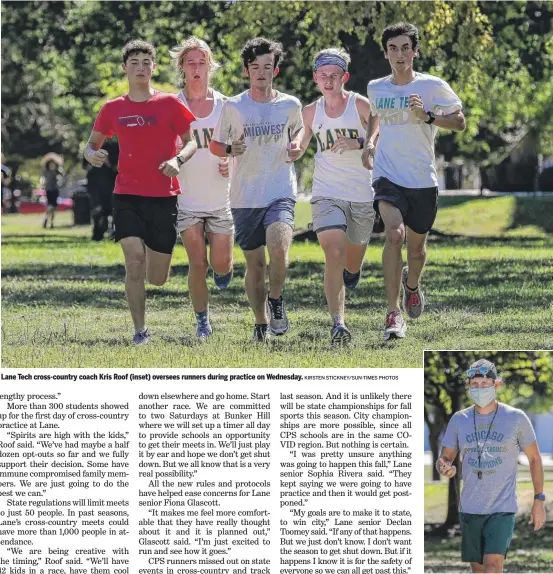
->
[[301, 48, 376, 344]]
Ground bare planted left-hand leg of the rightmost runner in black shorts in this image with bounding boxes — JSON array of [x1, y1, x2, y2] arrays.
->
[[379, 200, 405, 311]]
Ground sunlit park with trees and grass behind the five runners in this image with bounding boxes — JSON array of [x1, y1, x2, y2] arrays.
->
[[2, 1, 553, 367]]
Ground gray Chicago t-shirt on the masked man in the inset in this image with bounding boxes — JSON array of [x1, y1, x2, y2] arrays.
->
[[442, 403, 536, 514]]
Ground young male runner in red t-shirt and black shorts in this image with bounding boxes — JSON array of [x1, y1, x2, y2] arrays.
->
[[84, 40, 196, 345]]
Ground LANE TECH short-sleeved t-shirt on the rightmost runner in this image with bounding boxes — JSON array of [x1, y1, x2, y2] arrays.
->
[[367, 72, 462, 188]]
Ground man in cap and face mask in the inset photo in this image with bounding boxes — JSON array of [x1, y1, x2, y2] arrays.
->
[[436, 359, 545, 572]]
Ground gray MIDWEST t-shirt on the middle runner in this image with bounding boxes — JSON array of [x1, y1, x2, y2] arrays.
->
[[213, 91, 303, 208]]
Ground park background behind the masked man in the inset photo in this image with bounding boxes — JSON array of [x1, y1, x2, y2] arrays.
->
[[424, 351, 553, 573]]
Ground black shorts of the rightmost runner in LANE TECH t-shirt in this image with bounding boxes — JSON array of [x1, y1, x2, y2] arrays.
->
[[373, 177, 438, 235]]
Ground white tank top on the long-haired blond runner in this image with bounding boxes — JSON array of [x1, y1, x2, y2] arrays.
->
[[178, 90, 229, 211]]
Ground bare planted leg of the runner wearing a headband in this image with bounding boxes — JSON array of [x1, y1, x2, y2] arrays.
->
[[318, 229, 347, 324]]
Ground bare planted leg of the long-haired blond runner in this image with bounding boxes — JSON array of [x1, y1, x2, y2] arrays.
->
[[180, 222, 208, 313]]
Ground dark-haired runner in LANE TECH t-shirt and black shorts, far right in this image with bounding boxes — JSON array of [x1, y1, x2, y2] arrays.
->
[[363, 22, 465, 341]]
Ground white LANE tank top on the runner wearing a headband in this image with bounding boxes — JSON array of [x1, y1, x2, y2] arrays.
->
[[311, 92, 373, 202]]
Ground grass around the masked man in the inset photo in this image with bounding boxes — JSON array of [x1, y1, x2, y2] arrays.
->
[[424, 481, 553, 574]]
